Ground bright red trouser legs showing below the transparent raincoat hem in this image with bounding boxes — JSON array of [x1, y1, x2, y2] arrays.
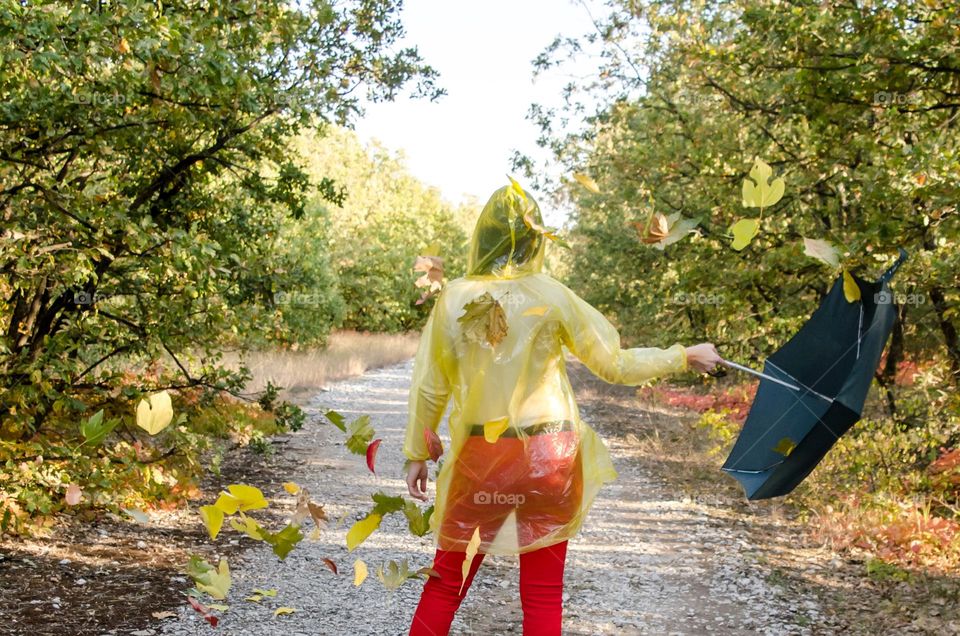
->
[[410, 541, 567, 636]]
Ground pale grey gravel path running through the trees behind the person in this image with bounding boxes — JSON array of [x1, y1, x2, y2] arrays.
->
[[158, 360, 819, 636]]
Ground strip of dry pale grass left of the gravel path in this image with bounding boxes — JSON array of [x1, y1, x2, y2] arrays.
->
[[224, 331, 419, 402]]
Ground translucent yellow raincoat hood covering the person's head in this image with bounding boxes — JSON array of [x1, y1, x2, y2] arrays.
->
[[467, 185, 546, 278]]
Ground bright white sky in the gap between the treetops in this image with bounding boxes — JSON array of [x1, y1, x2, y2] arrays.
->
[[355, 0, 591, 224]]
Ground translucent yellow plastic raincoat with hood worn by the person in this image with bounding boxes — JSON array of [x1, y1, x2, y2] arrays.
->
[[404, 181, 687, 554]]
